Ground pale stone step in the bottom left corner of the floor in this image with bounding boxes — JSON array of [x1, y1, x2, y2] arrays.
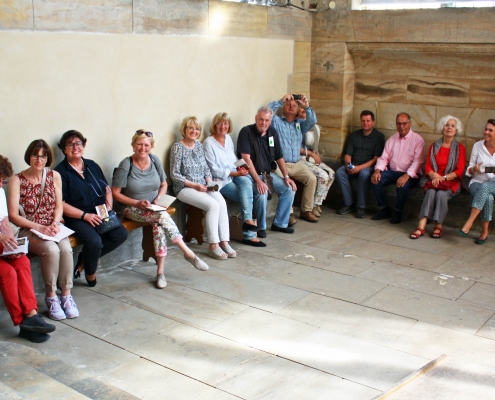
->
[[0, 341, 137, 400]]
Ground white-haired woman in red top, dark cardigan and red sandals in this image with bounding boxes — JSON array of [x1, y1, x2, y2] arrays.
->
[[410, 115, 466, 239]]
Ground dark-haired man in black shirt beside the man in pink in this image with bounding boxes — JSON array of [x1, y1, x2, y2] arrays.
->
[[335, 110, 385, 218]]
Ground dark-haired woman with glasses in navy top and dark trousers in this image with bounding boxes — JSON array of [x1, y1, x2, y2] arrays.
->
[[55, 130, 127, 287]]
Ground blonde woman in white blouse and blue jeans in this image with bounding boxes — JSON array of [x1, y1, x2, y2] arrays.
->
[[203, 113, 266, 247]]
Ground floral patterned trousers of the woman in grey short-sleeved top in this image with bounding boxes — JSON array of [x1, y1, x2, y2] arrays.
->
[[122, 207, 182, 257]]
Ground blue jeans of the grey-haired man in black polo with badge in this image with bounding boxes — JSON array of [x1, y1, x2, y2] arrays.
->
[[254, 172, 296, 230]]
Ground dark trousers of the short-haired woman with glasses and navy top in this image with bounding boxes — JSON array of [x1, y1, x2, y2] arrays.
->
[[65, 218, 128, 275]]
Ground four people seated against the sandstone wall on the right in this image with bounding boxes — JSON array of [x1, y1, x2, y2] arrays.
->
[[336, 110, 495, 244]]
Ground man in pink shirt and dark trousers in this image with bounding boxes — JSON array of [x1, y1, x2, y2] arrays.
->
[[371, 112, 425, 224]]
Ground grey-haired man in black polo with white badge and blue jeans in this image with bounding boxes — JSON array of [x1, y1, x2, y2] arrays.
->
[[237, 107, 296, 238]]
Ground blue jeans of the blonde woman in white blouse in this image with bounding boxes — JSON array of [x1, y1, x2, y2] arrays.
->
[[220, 175, 260, 240]]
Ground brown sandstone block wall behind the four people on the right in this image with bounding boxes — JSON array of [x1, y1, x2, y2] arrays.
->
[[311, 7, 495, 161]]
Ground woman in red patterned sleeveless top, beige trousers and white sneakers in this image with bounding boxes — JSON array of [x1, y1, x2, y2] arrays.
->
[[8, 139, 79, 321]]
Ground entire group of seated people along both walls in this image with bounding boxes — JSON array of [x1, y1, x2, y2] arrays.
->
[[0, 94, 495, 343]]
